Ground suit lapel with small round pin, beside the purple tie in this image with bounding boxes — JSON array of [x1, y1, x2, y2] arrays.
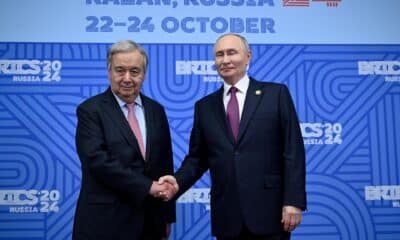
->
[[238, 78, 264, 142]]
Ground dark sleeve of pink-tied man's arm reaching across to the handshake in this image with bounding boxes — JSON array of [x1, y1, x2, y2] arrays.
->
[[76, 105, 152, 206]]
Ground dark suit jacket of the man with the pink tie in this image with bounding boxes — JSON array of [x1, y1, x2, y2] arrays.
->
[[73, 89, 175, 240]]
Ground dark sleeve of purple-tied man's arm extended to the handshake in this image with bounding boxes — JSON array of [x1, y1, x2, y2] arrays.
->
[[175, 102, 209, 196]]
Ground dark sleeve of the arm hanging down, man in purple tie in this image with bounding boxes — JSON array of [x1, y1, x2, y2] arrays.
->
[[280, 86, 306, 210]]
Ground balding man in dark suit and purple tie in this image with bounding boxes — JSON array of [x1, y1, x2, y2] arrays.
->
[[159, 34, 306, 240]]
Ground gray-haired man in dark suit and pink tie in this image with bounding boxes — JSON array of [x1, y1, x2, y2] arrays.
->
[[73, 40, 175, 240]]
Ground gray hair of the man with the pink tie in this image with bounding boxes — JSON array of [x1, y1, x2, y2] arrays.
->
[[107, 40, 149, 72]]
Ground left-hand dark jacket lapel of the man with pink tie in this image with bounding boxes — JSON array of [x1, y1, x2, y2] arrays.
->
[[103, 88, 147, 160]]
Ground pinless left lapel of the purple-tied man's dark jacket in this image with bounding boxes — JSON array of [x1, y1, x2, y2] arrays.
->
[[211, 86, 235, 144]]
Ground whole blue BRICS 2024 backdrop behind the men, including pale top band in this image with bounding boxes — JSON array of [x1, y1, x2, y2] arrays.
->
[[0, 0, 400, 240]]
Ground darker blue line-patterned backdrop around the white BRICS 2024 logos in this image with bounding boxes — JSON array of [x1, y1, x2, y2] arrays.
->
[[0, 43, 400, 239]]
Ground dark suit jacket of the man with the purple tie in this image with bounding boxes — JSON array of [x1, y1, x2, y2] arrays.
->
[[175, 79, 306, 237]]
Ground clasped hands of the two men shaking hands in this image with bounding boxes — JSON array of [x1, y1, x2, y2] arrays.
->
[[149, 175, 179, 201]]
